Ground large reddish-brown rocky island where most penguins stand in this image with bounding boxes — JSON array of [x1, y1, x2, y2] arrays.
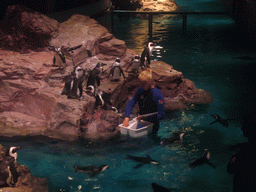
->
[[0, 4, 213, 140]]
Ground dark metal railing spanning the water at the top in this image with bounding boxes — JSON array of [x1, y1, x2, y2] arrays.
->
[[111, 10, 228, 36]]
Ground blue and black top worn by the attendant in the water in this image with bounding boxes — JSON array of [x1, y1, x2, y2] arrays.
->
[[125, 87, 165, 122]]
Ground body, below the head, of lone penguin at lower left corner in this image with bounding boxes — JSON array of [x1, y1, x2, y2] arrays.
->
[[0, 156, 19, 187]]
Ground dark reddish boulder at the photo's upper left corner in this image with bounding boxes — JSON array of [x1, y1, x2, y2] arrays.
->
[[0, 5, 58, 53]]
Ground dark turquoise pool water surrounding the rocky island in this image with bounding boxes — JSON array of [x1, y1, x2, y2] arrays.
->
[[1, 0, 256, 192]]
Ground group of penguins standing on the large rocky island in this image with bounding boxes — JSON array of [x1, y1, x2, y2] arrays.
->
[[60, 42, 154, 108]]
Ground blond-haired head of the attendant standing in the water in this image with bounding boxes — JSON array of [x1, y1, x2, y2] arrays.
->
[[138, 68, 155, 91]]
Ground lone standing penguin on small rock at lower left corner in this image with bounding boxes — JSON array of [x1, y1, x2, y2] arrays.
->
[[0, 146, 20, 187]]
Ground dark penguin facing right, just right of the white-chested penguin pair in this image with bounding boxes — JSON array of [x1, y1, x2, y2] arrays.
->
[[86, 63, 106, 89]]
